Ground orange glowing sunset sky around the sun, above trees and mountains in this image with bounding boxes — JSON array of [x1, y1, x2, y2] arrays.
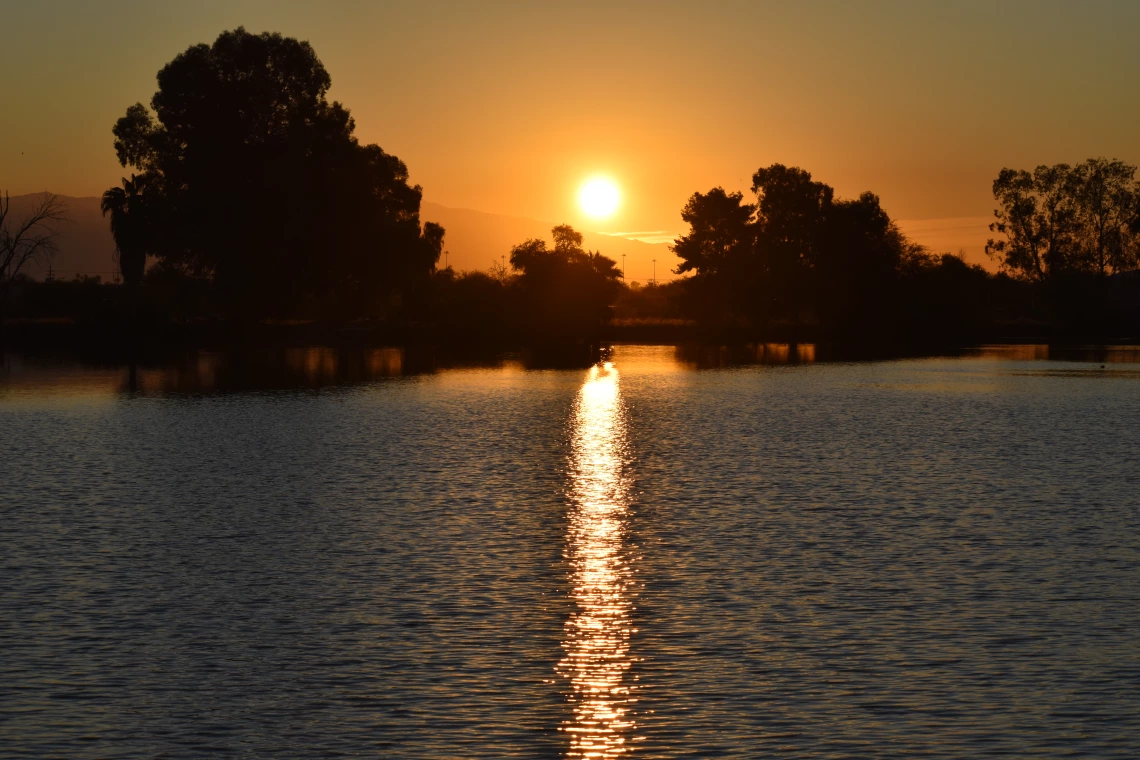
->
[[0, 0, 1140, 273]]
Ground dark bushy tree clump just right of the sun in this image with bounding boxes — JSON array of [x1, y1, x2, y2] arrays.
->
[[673, 164, 920, 324]]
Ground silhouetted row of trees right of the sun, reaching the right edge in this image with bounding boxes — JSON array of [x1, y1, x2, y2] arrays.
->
[[674, 160, 1140, 334]]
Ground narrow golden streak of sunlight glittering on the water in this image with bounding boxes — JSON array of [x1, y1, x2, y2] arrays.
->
[[559, 362, 635, 758]]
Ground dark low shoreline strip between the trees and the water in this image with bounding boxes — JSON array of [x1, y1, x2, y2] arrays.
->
[[0, 319, 1140, 371]]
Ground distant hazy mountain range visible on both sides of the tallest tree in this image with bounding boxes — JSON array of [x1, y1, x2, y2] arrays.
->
[[4, 194, 677, 283]]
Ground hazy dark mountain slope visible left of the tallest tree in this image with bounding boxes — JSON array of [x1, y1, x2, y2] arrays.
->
[[4, 193, 119, 280]]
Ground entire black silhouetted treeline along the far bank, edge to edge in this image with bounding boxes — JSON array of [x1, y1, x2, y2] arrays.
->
[[0, 28, 1140, 342]]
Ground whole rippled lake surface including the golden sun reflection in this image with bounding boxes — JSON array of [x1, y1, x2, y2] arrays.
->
[[0, 346, 1140, 758]]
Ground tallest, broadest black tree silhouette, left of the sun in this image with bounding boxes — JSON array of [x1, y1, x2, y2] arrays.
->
[[114, 27, 442, 316]]
